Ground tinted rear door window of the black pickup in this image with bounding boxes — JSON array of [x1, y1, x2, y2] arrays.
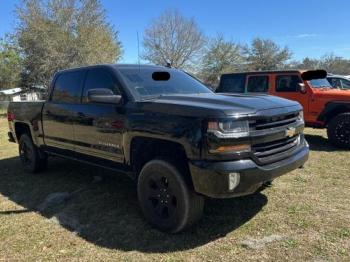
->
[[52, 71, 84, 103]]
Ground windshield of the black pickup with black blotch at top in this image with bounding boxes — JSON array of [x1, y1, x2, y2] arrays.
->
[[119, 68, 213, 98]]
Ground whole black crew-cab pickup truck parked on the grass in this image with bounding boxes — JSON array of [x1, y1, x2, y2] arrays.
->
[[8, 65, 309, 233]]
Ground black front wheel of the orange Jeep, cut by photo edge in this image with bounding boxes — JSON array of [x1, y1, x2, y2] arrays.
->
[[327, 113, 350, 148]]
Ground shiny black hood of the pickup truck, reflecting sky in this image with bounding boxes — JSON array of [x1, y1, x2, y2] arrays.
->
[[140, 93, 301, 117]]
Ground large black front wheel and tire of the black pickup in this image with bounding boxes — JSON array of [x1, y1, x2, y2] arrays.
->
[[138, 160, 204, 233]]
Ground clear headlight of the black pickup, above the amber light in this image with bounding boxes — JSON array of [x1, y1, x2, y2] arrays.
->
[[208, 120, 249, 138]]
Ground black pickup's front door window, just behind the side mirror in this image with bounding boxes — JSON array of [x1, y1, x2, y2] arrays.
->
[[83, 68, 120, 102]]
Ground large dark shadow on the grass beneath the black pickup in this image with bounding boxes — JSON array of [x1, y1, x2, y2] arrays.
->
[[0, 158, 267, 252]]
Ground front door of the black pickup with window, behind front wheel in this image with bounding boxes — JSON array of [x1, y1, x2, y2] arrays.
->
[[74, 67, 126, 162]]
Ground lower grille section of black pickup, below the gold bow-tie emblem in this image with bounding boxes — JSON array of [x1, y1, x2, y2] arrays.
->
[[252, 135, 300, 164]]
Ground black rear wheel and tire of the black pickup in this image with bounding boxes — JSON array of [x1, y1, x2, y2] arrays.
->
[[19, 134, 47, 173]]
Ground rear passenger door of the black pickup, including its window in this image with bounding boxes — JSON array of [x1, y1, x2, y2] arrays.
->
[[43, 70, 84, 154]]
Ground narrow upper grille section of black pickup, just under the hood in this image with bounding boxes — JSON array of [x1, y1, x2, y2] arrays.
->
[[249, 112, 299, 130]]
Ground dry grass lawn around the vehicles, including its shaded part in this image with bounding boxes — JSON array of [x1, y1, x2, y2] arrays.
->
[[0, 118, 350, 261]]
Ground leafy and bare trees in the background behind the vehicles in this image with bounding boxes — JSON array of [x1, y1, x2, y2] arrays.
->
[[0, 6, 350, 89]]
